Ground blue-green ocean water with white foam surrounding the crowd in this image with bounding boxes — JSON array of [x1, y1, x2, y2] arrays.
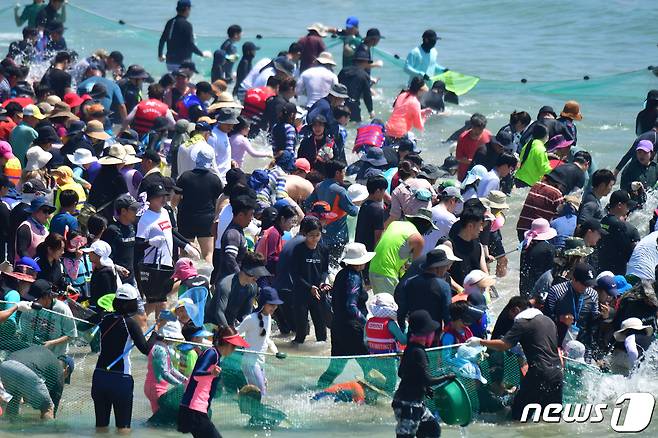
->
[[0, 0, 658, 438]]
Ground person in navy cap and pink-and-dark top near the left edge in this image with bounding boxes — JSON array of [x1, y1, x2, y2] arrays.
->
[[15, 196, 55, 259]]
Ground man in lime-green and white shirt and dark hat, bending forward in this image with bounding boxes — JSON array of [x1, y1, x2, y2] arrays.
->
[[368, 208, 436, 295]]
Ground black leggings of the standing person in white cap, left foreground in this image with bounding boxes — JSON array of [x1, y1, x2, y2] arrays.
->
[[91, 369, 135, 429]]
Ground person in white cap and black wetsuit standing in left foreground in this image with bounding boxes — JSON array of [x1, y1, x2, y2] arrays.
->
[[91, 284, 166, 434]]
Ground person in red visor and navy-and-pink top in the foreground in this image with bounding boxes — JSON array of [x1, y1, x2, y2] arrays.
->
[[178, 326, 249, 438]]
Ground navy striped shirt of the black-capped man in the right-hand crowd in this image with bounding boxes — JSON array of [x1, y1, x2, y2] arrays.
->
[[544, 281, 599, 329]]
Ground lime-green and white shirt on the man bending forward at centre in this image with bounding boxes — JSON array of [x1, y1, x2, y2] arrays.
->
[[370, 221, 418, 278]]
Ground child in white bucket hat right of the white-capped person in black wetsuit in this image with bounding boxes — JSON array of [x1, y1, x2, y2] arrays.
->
[[144, 321, 187, 415]]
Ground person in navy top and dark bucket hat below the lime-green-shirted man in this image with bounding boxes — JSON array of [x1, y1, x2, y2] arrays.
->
[[398, 248, 461, 330]]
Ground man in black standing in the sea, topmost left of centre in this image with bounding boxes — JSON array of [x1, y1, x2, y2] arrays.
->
[[158, 0, 212, 72]]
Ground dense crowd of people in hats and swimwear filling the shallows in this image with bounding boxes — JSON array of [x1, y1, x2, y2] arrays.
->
[[0, 0, 658, 437]]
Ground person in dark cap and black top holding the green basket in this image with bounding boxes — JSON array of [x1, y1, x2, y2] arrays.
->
[[391, 310, 455, 438]]
